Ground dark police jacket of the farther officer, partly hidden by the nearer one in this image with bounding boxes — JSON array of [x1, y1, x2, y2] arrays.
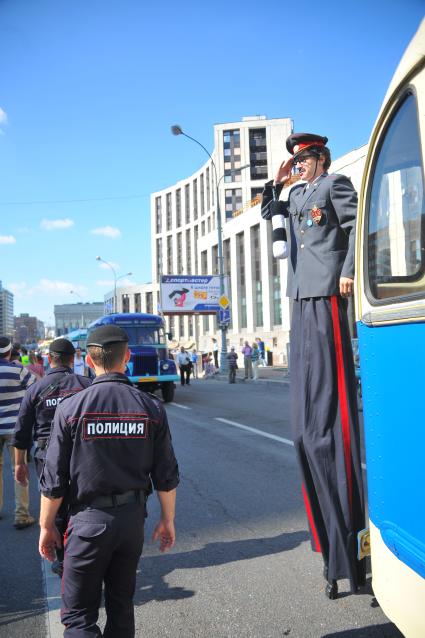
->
[[13, 366, 91, 450]]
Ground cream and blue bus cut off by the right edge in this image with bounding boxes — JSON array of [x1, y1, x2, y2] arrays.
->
[[356, 43, 425, 638]]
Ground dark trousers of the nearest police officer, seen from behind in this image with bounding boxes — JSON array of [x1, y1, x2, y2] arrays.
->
[[61, 501, 145, 638]]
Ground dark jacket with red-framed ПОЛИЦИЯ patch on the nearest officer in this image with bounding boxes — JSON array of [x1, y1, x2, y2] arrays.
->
[[40, 373, 179, 505]]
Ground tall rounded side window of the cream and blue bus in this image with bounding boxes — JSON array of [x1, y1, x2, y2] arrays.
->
[[365, 93, 425, 304]]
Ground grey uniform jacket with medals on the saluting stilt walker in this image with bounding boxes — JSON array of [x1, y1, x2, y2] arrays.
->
[[261, 173, 357, 299]]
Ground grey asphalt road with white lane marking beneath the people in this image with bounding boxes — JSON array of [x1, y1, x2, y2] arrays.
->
[[0, 379, 401, 638]]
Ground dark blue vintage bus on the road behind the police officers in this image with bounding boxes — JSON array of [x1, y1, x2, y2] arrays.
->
[[88, 313, 180, 403]]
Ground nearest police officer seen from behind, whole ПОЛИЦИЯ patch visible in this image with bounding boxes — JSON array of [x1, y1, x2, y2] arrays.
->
[[39, 325, 179, 638]]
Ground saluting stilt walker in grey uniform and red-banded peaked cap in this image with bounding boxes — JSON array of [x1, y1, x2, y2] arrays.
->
[[262, 133, 365, 598]]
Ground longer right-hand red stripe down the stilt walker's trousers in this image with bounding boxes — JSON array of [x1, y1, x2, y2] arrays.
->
[[331, 295, 353, 513]]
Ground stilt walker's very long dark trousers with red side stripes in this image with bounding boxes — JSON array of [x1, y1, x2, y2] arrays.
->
[[290, 296, 365, 591]]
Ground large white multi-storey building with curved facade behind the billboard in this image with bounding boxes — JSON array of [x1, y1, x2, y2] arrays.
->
[[110, 116, 366, 363]]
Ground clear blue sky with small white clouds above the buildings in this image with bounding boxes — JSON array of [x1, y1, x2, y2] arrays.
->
[[0, 0, 424, 322]]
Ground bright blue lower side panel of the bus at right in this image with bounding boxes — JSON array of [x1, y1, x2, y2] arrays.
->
[[358, 323, 425, 578]]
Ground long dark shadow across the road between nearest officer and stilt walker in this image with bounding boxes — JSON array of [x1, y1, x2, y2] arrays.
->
[[134, 531, 309, 605]]
